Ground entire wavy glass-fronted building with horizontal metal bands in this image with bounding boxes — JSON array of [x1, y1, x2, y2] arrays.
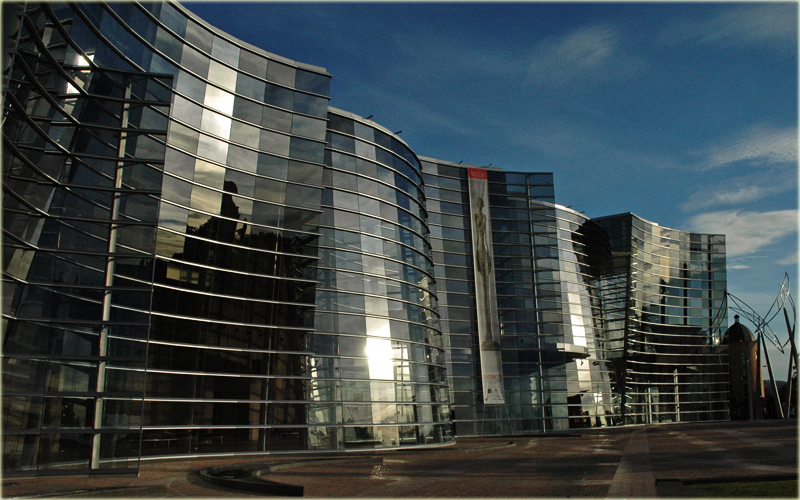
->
[[2, 2, 728, 475]]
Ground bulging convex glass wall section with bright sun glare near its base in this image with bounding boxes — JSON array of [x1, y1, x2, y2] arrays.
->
[[308, 109, 452, 449]]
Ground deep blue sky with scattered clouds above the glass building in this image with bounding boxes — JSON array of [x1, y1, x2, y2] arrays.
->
[[184, 2, 800, 380]]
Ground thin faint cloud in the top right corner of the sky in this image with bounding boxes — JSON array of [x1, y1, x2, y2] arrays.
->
[[657, 2, 797, 55]]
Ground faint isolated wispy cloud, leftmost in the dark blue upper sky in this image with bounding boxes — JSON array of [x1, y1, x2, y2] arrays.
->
[[528, 25, 644, 86]]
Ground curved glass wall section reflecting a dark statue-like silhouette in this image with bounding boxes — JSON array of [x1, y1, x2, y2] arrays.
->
[[142, 3, 330, 456]]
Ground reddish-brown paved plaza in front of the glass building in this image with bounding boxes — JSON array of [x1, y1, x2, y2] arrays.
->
[[2, 420, 798, 498]]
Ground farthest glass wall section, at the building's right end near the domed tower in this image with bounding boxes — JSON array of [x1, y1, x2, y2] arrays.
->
[[595, 214, 728, 424]]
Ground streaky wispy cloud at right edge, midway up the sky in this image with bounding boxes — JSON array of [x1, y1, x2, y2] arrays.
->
[[696, 124, 797, 169]]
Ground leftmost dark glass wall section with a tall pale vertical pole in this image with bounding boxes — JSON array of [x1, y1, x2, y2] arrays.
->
[[2, 2, 173, 474]]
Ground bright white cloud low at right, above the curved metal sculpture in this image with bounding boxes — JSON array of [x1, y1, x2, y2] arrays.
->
[[689, 209, 798, 257]]
